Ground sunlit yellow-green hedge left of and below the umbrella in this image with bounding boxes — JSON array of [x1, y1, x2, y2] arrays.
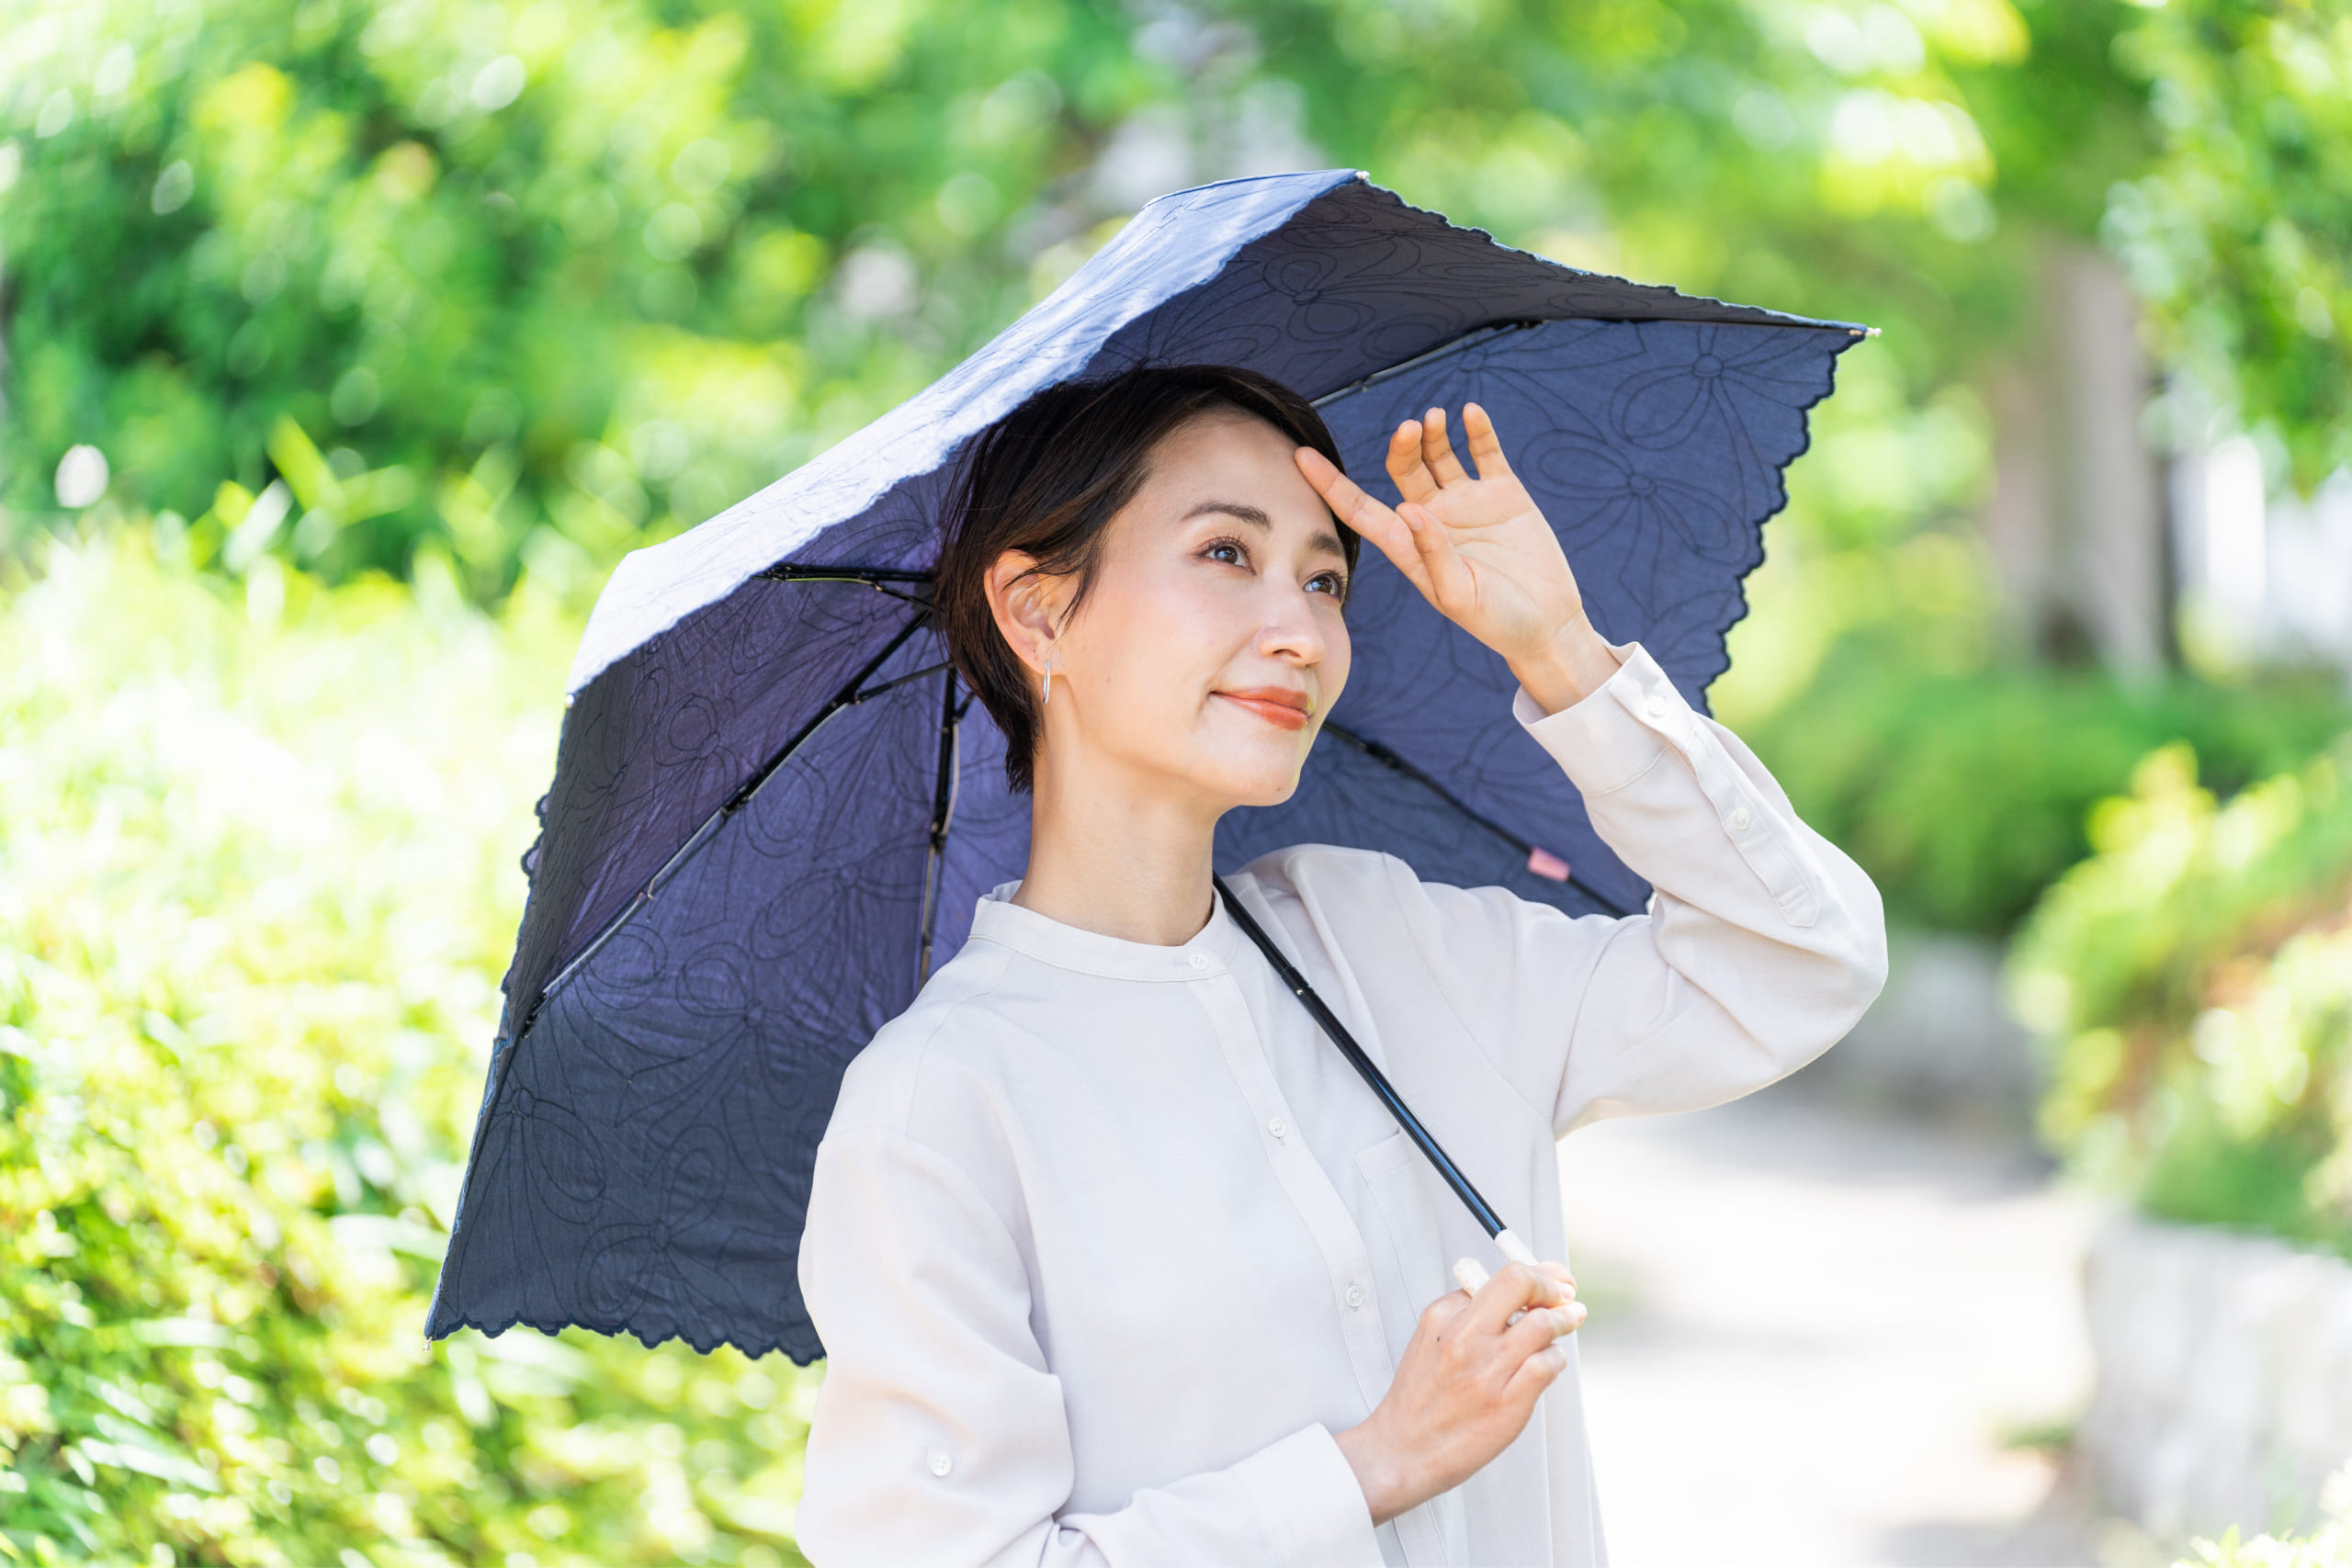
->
[[0, 536, 814, 1568]]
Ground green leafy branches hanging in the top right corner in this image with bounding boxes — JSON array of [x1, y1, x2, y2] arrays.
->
[[2108, 0, 2352, 489]]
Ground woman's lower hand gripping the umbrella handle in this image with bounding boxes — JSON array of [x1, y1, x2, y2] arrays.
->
[[1336, 1262, 1585, 1523]]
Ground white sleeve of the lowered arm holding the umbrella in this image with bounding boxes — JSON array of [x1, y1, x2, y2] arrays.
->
[[799, 1122, 1381, 1565]]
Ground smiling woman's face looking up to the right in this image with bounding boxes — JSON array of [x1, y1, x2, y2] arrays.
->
[[1016, 412, 1348, 816]]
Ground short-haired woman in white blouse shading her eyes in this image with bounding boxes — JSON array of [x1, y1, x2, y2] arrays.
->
[[799, 367, 1886, 1565]]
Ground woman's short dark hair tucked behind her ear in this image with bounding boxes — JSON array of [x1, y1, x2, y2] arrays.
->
[[932, 365, 1362, 792]]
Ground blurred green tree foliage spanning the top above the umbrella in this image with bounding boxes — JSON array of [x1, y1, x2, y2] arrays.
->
[[0, 0, 2182, 600]]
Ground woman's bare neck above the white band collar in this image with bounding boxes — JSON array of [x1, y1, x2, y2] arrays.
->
[[1013, 748, 1216, 947]]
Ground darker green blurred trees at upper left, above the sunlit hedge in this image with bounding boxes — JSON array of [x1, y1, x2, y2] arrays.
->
[[0, 0, 1155, 597]]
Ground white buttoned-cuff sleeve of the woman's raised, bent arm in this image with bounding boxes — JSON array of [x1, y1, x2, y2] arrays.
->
[[1397, 644, 1886, 1134]]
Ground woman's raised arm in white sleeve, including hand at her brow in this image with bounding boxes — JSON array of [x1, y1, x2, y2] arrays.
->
[[1298, 392, 1886, 1131]]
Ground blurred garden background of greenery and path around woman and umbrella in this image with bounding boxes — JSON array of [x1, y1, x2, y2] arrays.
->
[[0, 0, 2352, 1568]]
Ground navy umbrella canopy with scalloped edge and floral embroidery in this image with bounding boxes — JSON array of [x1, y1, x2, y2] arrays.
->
[[425, 169, 1863, 1361]]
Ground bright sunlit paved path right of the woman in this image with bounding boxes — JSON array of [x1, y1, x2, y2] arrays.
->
[[1562, 1084, 2096, 1568]]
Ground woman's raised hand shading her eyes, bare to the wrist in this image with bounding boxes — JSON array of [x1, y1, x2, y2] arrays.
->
[[1298, 402, 1618, 712]]
